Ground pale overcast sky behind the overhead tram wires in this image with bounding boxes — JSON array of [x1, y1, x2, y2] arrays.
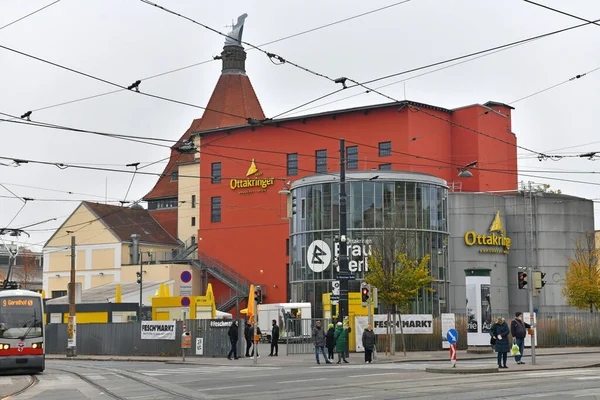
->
[[0, 0, 600, 249]]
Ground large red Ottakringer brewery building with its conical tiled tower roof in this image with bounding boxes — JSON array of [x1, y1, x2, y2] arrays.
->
[[146, 33, 517, 316]]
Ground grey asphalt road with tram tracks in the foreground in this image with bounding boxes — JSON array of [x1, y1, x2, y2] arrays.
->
[[7, 354, 600, 400]]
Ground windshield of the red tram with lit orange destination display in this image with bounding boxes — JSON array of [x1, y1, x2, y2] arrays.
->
[[0, 296, 43, 340]]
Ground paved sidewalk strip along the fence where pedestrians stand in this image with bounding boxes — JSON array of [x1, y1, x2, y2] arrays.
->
[[46, 347, 600, 372]]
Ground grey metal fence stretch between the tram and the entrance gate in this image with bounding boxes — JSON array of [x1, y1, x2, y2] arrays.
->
[[46, 320, 246, 357]]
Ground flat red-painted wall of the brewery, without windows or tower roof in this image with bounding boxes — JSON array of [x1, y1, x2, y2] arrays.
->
[[198, 106, 517, 303]]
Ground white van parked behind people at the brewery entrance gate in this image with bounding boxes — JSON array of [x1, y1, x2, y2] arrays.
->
[[258, 303, 312, 342]]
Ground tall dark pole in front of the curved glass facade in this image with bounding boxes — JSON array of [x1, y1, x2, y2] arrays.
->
[[338, 139, 349, 323]]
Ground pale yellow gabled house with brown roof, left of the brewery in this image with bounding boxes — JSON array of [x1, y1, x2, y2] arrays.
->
[[43, 202, 201, 301]]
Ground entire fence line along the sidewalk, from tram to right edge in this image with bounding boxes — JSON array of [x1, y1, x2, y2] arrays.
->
[[46, 313, 600, 357]]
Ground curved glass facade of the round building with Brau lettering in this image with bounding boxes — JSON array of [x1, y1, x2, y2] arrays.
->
[[289, 171, 449, 317]]
